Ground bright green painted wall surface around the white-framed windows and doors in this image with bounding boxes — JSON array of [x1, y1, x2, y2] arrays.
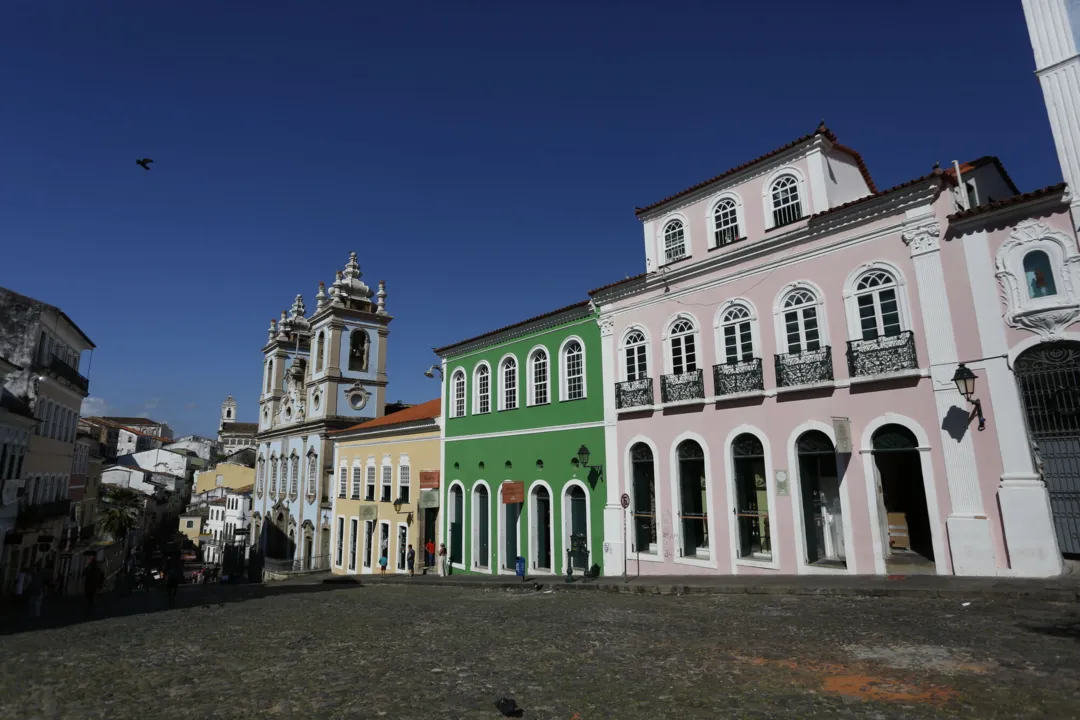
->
[[441, 314, 607, 575]]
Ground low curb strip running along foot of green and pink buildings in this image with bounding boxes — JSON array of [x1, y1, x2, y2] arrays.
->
[[345, 578, 1080, 602]]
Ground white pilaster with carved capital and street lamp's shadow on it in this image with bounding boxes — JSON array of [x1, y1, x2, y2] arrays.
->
[[903, 217, 997, 575]]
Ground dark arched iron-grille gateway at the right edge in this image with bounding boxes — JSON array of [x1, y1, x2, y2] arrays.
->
[[1013, 341, 1080, 556]]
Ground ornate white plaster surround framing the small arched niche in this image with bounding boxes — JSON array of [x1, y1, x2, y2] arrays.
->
[[995, 219, 1080, 338]]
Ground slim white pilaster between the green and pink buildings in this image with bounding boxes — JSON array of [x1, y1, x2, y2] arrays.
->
[[596, 311, 626, 575]]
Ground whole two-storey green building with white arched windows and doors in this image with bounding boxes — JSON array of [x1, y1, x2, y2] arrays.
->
[[435, 302, 607, 576]]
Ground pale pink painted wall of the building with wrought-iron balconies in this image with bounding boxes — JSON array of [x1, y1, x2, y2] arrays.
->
[[613, 201, 959, 574]]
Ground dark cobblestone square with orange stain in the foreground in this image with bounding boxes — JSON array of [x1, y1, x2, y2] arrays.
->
[[0, 581, 1080, 720]]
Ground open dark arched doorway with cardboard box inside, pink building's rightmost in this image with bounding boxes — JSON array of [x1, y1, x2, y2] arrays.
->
[[872, 424, 935, 572]]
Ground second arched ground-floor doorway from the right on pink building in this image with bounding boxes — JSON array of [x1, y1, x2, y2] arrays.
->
[[796, 430, 847, 568]]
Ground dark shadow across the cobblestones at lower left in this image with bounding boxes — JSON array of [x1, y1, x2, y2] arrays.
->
[[0, 576, 361, 636]]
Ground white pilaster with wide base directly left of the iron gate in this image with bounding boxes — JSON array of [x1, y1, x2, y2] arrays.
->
[[963, 230, 1062, 578]]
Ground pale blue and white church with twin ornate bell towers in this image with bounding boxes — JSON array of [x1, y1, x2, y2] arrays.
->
[[251, 253, 392, 570]]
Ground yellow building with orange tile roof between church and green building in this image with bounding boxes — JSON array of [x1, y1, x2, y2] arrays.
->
[[330, 399, 442, 574]]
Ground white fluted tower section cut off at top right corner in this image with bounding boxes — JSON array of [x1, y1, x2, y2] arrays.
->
[[1023, 0, 1080, 228]]
